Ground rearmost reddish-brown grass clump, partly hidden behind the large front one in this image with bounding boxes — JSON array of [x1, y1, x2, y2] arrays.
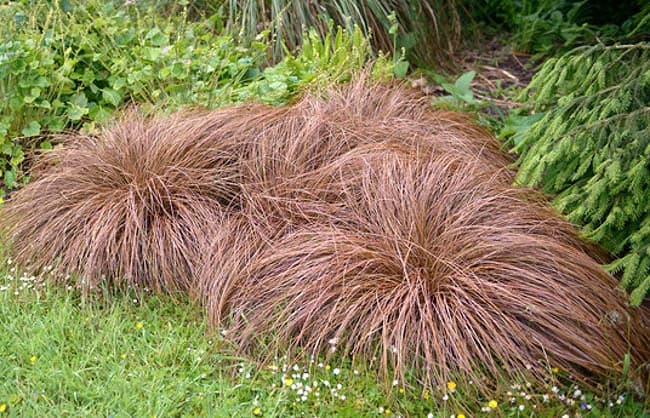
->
[[235, 78, 514, 225]]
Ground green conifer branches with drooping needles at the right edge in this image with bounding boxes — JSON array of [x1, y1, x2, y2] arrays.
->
[[514, 42, 650, 305]]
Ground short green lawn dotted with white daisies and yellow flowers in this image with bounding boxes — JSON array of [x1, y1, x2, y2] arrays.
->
[[0, 253, 648, 418]]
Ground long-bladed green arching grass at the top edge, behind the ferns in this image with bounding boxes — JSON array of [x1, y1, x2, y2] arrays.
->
[[228, 0, 464, 69]]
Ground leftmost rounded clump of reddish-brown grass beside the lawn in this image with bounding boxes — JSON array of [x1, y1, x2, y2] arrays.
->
[[1, 110, 256, 292]]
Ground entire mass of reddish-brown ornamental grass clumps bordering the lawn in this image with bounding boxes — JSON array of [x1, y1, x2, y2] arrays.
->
[[1, 80, 650, 396]]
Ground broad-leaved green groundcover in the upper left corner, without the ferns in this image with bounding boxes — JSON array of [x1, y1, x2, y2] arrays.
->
[[0, 1, 264, 188]]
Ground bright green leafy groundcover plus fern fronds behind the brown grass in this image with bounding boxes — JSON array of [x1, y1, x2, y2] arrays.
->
[[0, 1, 393, 196]]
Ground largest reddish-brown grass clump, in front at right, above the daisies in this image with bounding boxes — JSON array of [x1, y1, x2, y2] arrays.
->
[[206, 149, 648, 392]]
